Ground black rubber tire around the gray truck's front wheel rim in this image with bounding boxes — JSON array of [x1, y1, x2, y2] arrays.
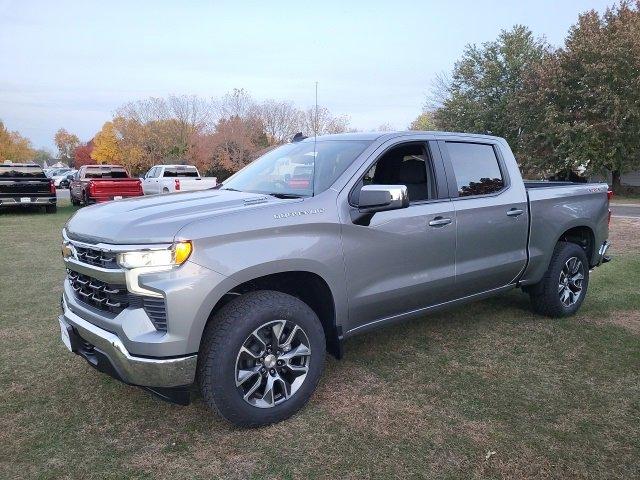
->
[[196, 290, 326, 427]]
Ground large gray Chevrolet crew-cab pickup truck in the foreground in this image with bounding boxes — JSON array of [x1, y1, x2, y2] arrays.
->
[[59, 132, 610, 426]]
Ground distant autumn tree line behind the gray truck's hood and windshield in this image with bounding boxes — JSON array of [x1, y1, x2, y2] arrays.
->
[[55, 89, 349, 178]]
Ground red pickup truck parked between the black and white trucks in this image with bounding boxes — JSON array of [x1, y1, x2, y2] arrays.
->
[[69, 165, 142, 205]]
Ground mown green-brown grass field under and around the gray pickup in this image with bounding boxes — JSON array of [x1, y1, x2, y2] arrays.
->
[[0, 206, 640, 479]]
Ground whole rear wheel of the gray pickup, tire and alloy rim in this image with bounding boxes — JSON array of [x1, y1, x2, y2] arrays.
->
[[529, 242, 589, 317]]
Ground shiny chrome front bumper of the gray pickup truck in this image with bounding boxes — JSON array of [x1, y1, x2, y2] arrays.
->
[[59, 301, 198, 387]]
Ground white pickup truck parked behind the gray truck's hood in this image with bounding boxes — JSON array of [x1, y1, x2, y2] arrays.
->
[[142, 165, 217, 195]]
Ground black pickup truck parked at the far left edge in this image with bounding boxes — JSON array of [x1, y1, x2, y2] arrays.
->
[[0, 163, 57, 213]]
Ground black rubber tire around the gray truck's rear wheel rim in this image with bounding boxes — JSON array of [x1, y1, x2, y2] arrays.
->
[[529, 242, 589, 318]]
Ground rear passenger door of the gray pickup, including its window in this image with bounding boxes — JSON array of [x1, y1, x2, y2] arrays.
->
[[438, 139, 529, 298]]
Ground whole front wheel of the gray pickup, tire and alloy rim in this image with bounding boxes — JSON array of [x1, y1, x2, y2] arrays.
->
[[197, 290, 326, 427]]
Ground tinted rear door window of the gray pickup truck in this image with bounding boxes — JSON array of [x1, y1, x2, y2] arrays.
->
[[446, 142, 505, 197]]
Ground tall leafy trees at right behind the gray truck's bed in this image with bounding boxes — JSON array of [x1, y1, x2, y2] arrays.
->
[[412, 1, 640, 191]]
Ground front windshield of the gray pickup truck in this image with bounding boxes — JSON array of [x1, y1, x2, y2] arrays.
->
[[222, 140, 371, 197]]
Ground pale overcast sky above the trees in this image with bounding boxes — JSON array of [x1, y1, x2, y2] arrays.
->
[[0, 0, 613, 149]]
